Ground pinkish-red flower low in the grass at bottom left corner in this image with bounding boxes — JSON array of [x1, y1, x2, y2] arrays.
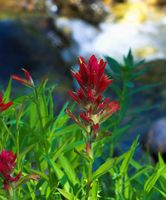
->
[[0, 150, 21, 190]]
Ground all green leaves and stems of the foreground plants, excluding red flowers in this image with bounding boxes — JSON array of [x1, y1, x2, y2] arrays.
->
[[0, 50, 166, 200]]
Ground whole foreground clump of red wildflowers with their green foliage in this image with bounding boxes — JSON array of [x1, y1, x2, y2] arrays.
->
[[0, 51, 163, 200]]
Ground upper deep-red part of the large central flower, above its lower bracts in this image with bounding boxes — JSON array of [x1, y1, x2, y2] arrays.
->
[[70, 55, 112, 105]]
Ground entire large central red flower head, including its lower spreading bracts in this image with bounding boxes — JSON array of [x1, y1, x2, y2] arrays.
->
[[67, 55, 120, 156]]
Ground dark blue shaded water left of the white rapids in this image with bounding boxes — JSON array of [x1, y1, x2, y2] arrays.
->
[[0, 20, 69, 86]]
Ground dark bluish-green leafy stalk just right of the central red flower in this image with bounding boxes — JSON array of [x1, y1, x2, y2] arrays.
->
[[105, 49, 160, 144]]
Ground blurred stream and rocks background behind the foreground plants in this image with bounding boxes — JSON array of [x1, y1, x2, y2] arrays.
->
[[0, 0, 166, 159]]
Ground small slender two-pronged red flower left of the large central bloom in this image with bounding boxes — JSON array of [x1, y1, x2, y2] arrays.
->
[[12, 68, 34, 87]]
